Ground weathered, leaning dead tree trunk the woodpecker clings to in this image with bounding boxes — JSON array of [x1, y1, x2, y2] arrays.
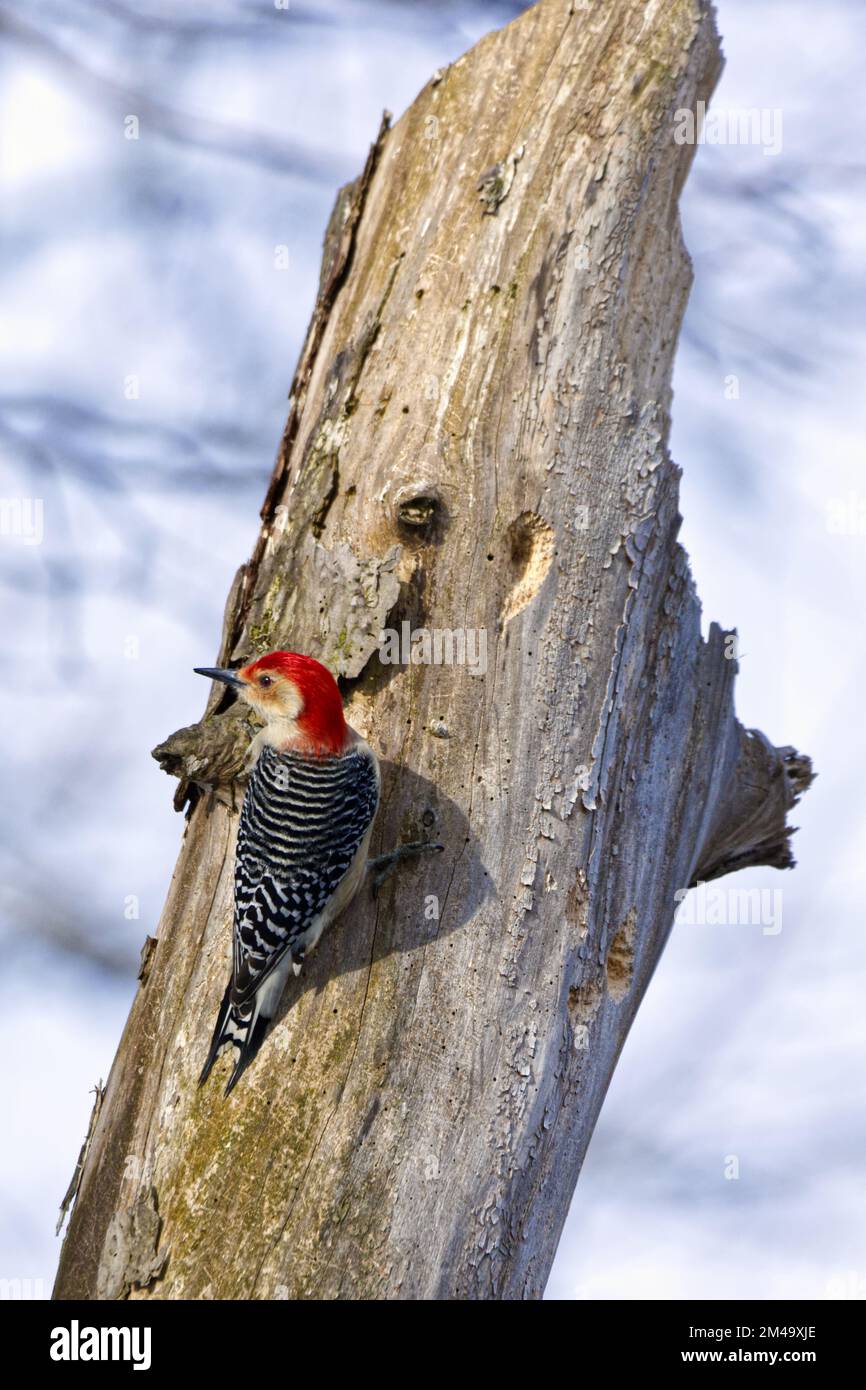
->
[[56, 0, 809, 1298]]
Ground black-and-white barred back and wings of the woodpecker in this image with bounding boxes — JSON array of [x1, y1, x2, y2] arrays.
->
[[231, 745, 378, 1005]]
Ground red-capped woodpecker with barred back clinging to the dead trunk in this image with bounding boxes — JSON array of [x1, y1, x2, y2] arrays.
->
[[196, 652, 442, 1094]]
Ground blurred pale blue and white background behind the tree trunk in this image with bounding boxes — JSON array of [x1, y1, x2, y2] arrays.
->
[[0, 0, 866, 1298]]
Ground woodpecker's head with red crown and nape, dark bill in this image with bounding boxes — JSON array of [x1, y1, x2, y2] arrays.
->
[[195, 652, 348, 753]]
